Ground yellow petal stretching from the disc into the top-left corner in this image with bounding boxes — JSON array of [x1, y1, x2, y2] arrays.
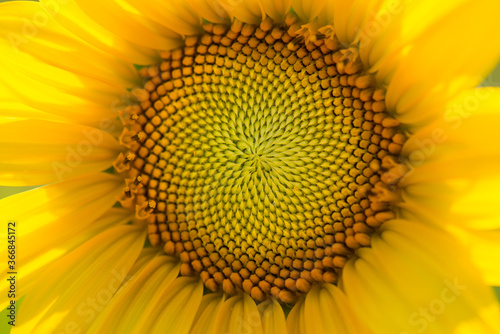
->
[[0, 2, 140, 88]]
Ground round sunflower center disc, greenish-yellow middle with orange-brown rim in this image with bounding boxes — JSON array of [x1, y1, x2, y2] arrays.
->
[[115, 16, 405, 303]]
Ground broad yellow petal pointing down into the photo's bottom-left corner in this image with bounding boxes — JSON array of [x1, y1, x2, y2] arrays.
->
[[12, 225, 146, 334]]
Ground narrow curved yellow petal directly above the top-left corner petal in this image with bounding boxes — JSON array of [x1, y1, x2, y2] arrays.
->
[[40, 0, 159, 65]]
